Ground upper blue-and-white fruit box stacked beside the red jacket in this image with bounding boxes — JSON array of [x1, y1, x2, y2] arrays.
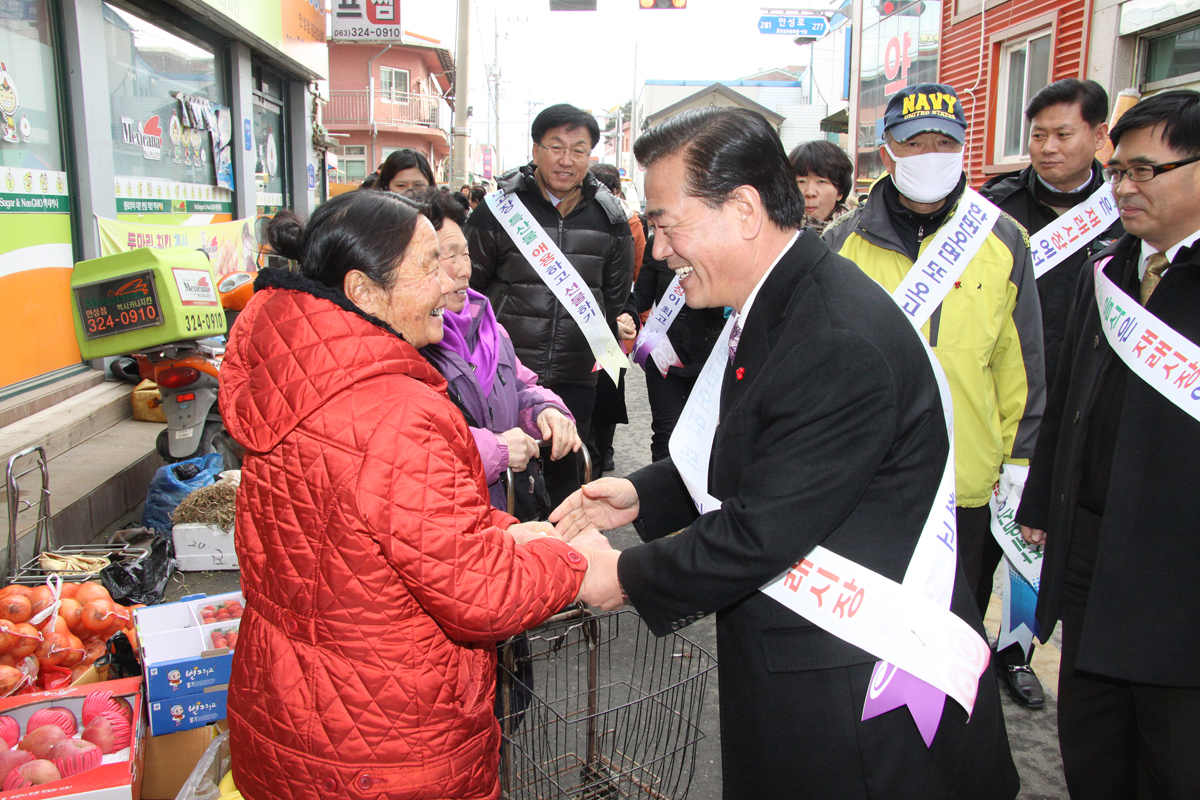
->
[[133, 591, 245, 705]]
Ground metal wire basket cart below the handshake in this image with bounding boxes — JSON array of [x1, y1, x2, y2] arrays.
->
[[497, 608, 716, 800]]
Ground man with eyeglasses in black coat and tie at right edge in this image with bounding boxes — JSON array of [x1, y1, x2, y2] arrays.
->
[[1016, 91, 1200, 800]]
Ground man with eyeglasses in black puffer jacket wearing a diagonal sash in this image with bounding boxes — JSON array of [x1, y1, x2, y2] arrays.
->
[[463, 103, 634, 505]]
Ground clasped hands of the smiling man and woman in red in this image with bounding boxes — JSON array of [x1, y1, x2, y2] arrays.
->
[[508, 477, 640, 610]]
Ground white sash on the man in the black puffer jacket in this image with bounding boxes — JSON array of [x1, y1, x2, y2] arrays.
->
[[485, 190, 629, 384]]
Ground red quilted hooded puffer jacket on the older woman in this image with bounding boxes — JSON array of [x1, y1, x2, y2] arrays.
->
[[221, 270, 587, 800]]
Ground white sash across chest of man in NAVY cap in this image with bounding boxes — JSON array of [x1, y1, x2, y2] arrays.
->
[[892, 186, 1001, 331]]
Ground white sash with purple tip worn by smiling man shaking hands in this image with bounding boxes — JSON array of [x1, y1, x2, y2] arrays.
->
[[670, 283, 989, 726]]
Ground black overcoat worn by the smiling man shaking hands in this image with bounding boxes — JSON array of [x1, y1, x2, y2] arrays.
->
[[618, 231, 1018, 800]]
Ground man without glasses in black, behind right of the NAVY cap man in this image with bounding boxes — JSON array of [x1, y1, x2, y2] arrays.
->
[[979, 78, 1124, 708]]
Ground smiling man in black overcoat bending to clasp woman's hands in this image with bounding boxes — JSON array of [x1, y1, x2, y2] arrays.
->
[[551, 108, 1019, 800]]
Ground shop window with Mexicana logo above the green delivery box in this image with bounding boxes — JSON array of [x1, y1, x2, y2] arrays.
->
[[104, 4, 233, 213]]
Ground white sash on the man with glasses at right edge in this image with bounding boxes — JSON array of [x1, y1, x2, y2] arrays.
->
[[1094, 258, 1200, 420]]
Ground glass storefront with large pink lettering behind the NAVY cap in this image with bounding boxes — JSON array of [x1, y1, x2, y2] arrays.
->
[[854, 0, 942, 192]]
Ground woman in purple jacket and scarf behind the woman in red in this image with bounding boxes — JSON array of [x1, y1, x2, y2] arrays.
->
[[407, 188, 581, 513]]
